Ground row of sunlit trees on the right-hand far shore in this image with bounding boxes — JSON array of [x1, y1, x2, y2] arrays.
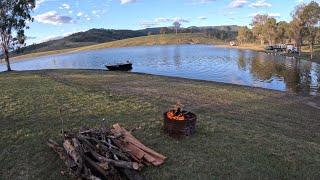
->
[[237, 1, 320, 59]]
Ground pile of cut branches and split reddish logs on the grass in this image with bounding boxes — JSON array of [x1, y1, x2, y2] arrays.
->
[[47, 124, 166, 180]]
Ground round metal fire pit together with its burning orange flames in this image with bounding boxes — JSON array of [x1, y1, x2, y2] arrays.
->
[[163, 104, 197, 138]]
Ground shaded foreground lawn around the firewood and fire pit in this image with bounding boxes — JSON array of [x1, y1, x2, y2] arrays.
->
[[0, 70, 320, 179]]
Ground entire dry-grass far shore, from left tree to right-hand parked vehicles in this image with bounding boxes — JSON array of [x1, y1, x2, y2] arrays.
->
[[0, 33, 320, 63]]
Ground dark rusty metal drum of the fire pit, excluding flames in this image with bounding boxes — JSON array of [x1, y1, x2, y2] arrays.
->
[[163, 111, 197, 138]]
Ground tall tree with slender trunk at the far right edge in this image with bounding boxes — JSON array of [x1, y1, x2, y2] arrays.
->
[[301, 1, 320, 59]]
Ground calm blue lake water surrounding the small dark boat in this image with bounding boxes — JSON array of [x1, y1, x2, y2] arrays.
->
[[0, 45, 320, 95]]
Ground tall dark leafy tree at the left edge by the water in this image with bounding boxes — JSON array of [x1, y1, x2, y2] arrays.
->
[[0, 0, 35, 71]]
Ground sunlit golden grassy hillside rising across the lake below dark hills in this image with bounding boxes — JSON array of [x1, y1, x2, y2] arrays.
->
[[13, 33, 224, 60]]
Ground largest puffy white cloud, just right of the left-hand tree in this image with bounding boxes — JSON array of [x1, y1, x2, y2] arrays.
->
[[34, 11, 73, 25]]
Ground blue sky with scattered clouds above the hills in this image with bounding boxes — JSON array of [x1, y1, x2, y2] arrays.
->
[[26, 0, 311, 44]]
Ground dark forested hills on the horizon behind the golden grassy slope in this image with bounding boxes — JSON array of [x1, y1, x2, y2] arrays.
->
[[12, 26, 239, 56]]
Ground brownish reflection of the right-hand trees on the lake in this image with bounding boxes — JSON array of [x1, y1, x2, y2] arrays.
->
[[248, 55, 319, 94]]
